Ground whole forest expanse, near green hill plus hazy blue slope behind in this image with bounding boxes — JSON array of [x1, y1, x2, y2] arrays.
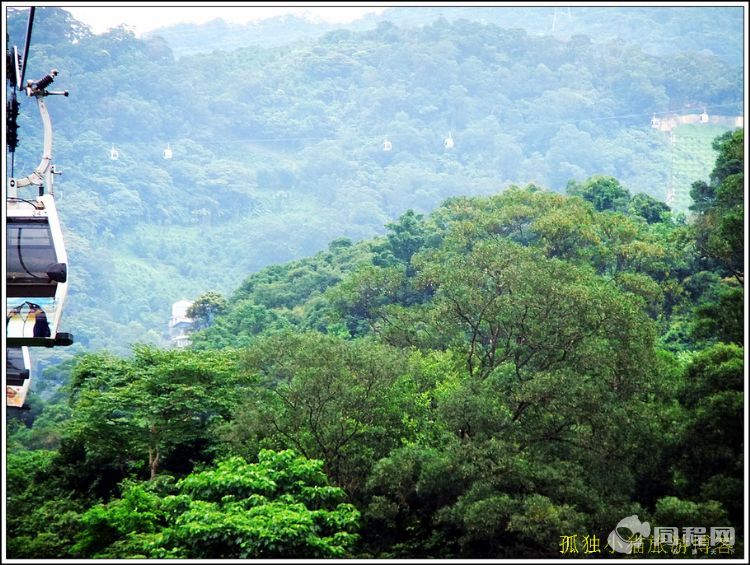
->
[[5, 4, 746, 559]]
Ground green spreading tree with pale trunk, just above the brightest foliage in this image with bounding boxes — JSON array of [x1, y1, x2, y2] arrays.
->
[[67, 346, 247, 478]]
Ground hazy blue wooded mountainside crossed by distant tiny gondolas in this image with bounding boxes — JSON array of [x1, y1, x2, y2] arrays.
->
[[8, 8, 742, 362]]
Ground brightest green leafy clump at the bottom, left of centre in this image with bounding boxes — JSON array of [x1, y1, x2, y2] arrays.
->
[[74, 450, 359, 559]]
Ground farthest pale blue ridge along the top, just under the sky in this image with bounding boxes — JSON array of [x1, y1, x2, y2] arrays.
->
[[147, 5, 743, 64]]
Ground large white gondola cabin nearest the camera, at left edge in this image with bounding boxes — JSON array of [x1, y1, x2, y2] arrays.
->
[[5, 194, 72, 347]]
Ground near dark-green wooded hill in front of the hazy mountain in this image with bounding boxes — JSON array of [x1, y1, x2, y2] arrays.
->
[[7, 130, 745, 558]]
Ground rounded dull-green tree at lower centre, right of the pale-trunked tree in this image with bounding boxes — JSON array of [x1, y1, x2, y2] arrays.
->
[[228, 332, 418, 493]]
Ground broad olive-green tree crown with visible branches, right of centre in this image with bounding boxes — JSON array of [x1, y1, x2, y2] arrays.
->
[[419, 236, 653, 386]]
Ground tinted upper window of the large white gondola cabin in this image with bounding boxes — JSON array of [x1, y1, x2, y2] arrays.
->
[[6, 218, 59, 284]]
